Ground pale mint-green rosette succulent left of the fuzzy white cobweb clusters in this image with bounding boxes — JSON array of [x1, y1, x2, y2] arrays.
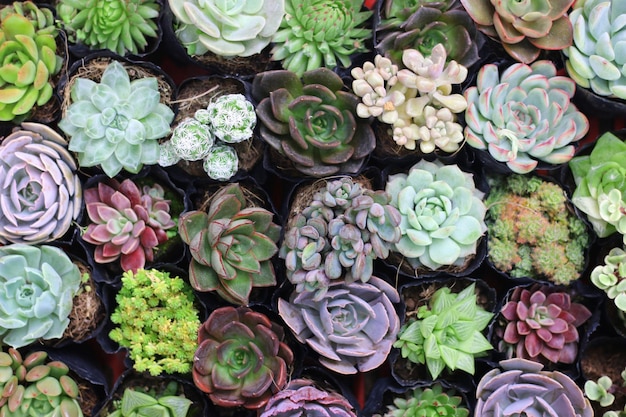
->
[[59, 60, 174, 178]]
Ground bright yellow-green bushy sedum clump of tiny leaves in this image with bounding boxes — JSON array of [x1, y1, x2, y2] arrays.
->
[[109, 269, 200, 376]]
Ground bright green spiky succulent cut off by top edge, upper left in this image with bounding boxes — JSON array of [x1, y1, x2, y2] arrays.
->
[[56, 0, 161, 55]]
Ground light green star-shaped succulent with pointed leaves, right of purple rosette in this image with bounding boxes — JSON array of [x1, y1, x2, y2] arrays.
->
[[393, 283, 493, 379]]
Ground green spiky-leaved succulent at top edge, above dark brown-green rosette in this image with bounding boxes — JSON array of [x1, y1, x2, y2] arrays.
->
[[272, 0, 372, 76]]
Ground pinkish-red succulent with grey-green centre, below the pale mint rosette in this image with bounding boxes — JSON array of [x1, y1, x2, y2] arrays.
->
[[82, 179, 176, 271]]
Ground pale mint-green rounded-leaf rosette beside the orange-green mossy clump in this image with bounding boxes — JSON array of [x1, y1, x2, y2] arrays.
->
[[385, 160, 487, 270]]
